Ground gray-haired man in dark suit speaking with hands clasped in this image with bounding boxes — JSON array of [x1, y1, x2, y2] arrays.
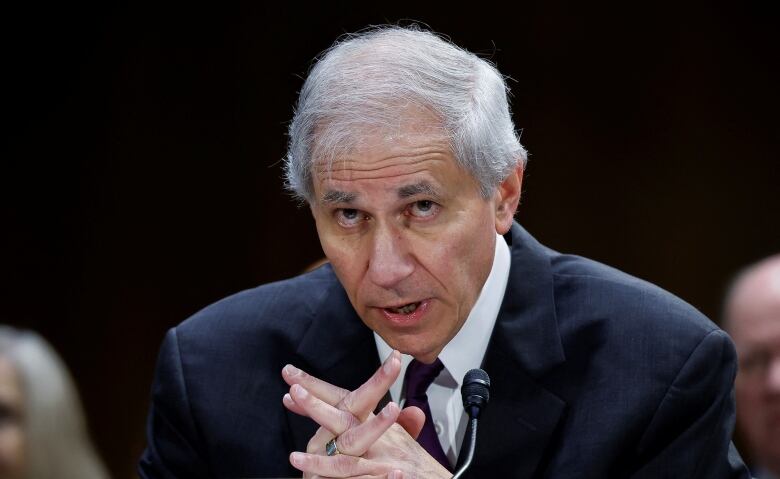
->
[[139, 27, 746, 478]]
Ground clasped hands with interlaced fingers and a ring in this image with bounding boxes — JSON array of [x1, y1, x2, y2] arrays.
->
[[282, 351, 452, 479]]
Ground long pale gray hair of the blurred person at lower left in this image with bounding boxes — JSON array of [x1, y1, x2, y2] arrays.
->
[[0, 326, 108, 479]]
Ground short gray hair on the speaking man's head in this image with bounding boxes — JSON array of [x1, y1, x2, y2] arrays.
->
[[285, 26, 527, 202]]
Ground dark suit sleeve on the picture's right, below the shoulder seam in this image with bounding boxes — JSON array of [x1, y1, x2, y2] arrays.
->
[[631, 330, 750, 479]]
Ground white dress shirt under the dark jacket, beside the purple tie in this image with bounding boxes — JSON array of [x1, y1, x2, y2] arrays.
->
[[374, 235, 511, 465]]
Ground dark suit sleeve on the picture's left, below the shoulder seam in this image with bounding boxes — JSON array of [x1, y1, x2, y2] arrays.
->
[[138, 328, 210, 479]]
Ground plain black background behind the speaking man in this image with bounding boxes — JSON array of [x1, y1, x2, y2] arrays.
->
[[0, 1, 780, 478]]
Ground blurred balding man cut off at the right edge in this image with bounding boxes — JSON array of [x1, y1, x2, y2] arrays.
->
[[724, 255, 780, 479]]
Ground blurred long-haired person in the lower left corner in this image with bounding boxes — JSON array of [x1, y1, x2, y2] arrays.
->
[[0, 326, 108, 479]]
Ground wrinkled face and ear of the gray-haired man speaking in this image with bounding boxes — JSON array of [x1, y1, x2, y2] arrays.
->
[[311, 118, 521, 362]]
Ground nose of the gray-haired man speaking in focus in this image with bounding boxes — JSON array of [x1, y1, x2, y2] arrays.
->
[[368, 226, 414, 289]]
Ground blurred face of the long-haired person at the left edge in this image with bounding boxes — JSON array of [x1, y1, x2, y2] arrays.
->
[[0, 357, 25, 479]]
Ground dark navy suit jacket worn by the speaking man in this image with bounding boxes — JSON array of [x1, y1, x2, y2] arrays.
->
[[139, 224, 748, 479]]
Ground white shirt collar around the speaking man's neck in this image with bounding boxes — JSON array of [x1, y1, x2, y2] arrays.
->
[[374, 235, 511, 402]]
